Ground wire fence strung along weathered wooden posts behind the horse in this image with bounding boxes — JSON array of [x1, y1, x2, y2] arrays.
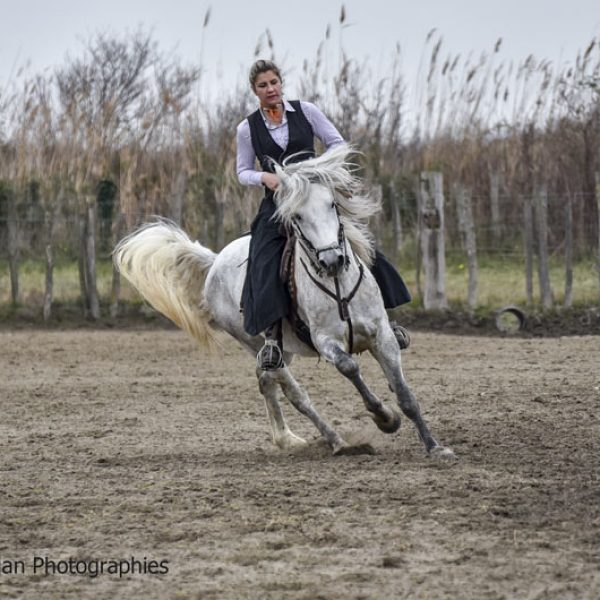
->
[[0, 184, 600, 311]]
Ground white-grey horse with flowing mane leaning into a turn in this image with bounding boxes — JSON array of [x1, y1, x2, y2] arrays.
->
[[114, 146, 454, 457]]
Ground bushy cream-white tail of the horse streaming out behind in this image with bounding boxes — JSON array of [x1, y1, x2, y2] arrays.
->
[[113, 220, 216, 346]]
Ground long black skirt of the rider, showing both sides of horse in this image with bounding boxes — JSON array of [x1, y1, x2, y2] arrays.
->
[[242, 194, 411, 335]]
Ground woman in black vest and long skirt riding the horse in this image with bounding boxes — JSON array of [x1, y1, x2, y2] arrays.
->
[[237, 60, 411, 370]]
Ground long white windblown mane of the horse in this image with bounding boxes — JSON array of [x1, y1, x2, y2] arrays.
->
[[275, 144, 381, 266]]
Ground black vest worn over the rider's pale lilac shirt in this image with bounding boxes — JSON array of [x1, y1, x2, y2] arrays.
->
[[248, 100, 315, 173]]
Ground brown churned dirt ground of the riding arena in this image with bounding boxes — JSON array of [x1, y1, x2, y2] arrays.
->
[[0, 329, 600, 600]]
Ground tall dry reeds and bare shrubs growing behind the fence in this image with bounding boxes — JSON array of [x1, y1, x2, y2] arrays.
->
[[0, 8, 600, 310]]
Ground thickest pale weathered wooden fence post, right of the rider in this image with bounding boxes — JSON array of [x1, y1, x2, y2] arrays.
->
[[419, 172, 448, 309]]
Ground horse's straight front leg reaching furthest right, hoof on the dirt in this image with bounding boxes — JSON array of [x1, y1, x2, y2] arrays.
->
[[371, 323, 455, 458]]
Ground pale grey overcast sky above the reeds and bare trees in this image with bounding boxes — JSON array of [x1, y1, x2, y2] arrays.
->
[[0, 0, 600, 99]]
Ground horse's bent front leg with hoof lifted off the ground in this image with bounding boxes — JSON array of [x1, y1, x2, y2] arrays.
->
[[317, 336, 400, 433]]
